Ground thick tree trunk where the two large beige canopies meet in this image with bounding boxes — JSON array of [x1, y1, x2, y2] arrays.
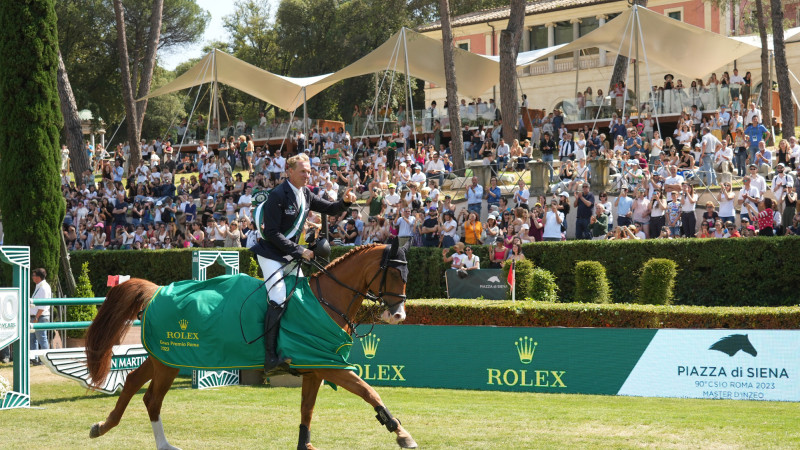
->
[[500, 0, 525, 145]]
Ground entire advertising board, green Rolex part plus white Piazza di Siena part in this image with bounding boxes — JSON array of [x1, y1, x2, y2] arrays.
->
[[350, 325, 800, 401]]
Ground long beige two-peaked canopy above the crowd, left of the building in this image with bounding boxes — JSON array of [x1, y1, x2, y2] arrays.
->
[[144, 28, 500, 111]]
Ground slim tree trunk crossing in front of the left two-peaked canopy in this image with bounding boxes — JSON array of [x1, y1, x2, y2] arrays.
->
[[437, 0, 465, 173]]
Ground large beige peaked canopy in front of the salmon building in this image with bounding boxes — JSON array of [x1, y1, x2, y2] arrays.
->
[[532, 5, 756, 78]]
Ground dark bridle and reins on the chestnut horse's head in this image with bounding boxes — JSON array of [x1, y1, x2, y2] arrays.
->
[[310, 247, 408, 338]]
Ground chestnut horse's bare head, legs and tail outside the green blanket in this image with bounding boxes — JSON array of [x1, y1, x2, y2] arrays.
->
[[86, 240, 417, 449]]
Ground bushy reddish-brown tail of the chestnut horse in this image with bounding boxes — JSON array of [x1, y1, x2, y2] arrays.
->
[[86, 278, 158, 387]]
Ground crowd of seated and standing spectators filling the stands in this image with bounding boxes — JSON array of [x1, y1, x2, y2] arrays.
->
[[62, 79, 800, 258]]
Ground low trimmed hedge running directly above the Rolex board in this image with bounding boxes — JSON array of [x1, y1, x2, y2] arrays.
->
[[403, 299, 800, 329]]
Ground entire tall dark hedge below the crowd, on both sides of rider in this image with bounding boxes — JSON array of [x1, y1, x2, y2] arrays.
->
[[64, 236, 800, 306]]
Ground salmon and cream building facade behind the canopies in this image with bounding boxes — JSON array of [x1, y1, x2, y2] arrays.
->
[[418, 0, 800, 123]]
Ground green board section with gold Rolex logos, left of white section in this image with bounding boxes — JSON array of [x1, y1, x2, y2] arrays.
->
[[350, 325, 656, 395]]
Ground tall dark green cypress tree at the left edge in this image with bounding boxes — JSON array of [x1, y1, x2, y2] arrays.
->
[[0, 0, 65, 282]]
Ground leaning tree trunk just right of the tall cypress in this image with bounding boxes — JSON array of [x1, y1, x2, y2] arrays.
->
[[58, 51, 92, 180]]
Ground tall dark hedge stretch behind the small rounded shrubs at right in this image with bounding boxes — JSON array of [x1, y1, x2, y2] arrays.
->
[[524, 236, 800, 306]]
